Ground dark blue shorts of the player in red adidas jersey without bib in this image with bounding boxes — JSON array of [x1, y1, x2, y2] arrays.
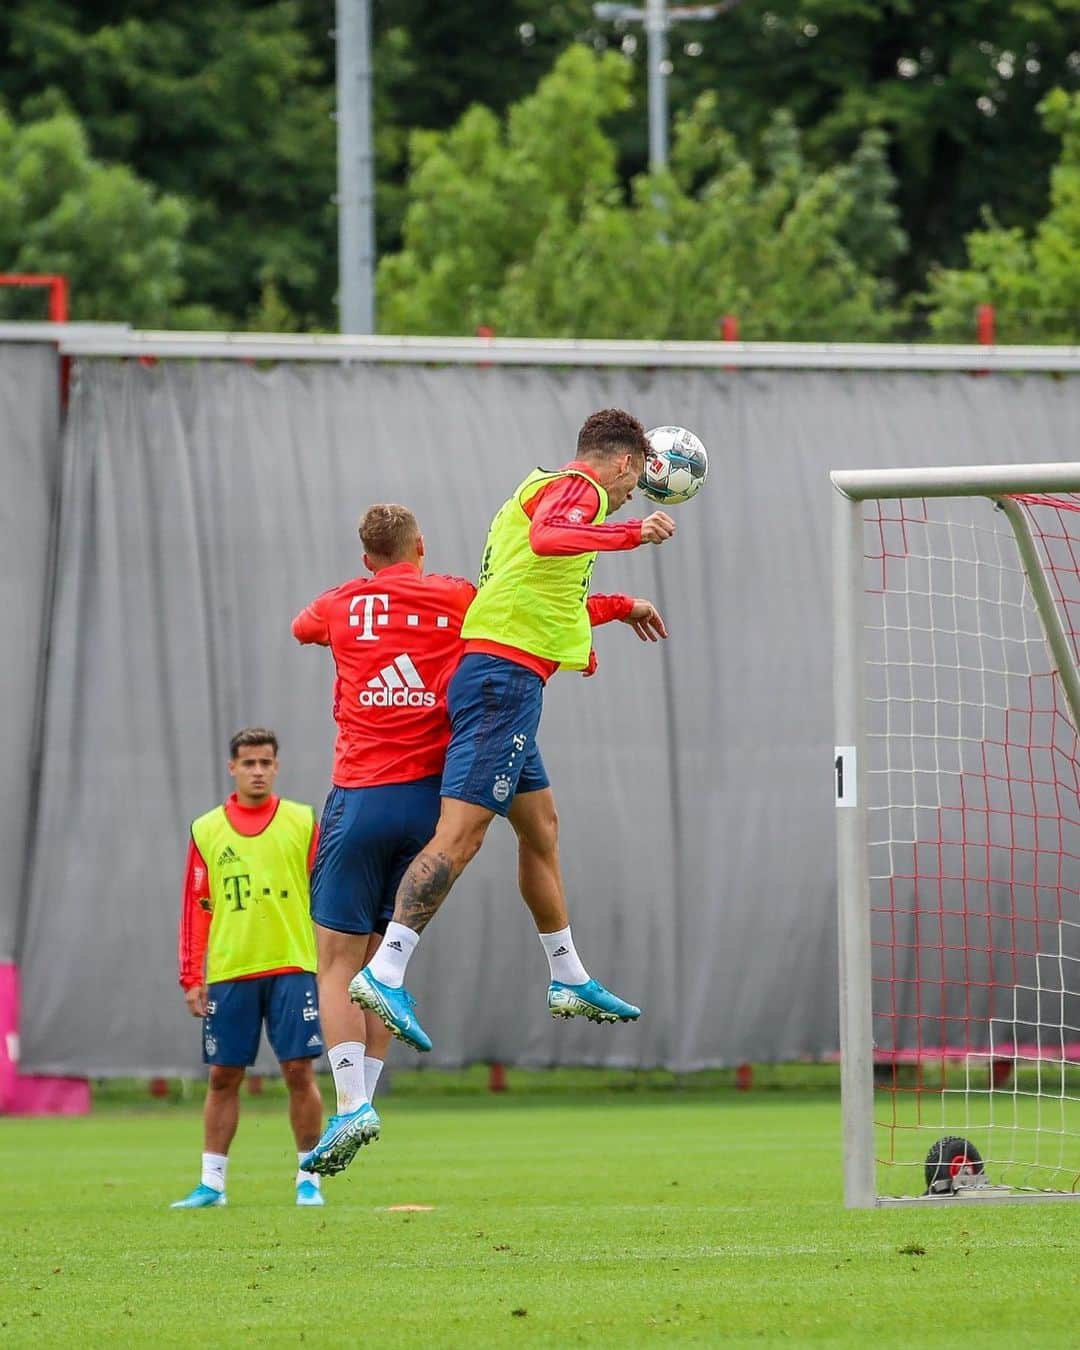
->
[[312, 775, 439, 933]]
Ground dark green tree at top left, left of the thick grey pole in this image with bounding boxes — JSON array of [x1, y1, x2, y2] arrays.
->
[[0, 0, 338, 327]]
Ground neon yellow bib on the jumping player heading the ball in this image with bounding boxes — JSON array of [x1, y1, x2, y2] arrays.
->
[[462, 468, 608, 670]]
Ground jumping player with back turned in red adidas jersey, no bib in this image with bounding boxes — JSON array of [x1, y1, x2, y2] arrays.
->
[[293, 504, 475, 1176]]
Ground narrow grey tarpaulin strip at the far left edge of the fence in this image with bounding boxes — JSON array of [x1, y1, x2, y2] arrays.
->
[[0, 343, 59, 961]]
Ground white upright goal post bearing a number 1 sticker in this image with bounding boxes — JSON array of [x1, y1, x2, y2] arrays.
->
[[833, 491, 876, 1208]]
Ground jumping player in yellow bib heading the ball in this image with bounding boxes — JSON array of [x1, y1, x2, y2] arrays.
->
[[350, 408, 675, 1050]]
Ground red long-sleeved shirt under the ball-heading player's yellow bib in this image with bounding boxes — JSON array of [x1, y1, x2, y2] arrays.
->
[[464, 459, 641, 683]]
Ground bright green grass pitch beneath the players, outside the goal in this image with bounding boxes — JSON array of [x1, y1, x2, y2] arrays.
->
[[0, 1073, 1080, 1350]]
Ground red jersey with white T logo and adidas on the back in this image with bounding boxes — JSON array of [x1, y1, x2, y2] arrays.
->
[[293, 563, 477, 787]]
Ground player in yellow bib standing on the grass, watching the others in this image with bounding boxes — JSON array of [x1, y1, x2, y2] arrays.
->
[[173, 728, 323, 1210]]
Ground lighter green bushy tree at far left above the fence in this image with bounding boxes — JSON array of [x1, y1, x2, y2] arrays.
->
[[0, 107, 205, 327]]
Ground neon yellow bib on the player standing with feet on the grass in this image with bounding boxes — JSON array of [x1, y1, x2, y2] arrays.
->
[[192, 798, 316, 983]]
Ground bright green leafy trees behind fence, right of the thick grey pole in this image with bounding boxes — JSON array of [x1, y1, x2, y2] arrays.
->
[[378, 46, 905, 339]]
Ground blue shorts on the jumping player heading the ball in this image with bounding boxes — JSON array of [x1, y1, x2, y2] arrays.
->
[[443, 652, 549, 815]]
